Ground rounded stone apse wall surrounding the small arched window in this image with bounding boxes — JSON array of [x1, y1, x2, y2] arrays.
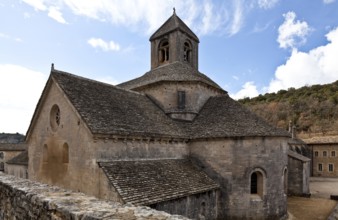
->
[[190, 137, 288, 219]]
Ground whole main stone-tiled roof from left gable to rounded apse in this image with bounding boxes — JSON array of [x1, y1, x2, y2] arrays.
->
[[46, 70, 290, 138]]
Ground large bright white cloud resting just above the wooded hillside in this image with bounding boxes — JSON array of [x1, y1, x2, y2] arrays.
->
[[267, 27, 338, 92]]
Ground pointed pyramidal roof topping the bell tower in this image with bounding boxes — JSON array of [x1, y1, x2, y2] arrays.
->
[[149, 12, 199, 42]]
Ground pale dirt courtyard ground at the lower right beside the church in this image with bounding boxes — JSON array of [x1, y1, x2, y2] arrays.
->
[[288, 177, 338, 220]]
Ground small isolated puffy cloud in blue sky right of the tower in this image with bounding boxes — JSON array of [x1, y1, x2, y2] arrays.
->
[[277, 11, 311, 49]]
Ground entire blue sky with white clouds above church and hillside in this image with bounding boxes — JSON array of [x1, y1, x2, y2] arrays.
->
[[0, 0, 338, 134]]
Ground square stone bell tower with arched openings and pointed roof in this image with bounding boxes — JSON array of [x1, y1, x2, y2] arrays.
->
[[149, 9, 199, 70]]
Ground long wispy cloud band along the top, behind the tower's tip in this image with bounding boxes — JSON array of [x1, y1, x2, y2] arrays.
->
[[23, 0, 256, 35]]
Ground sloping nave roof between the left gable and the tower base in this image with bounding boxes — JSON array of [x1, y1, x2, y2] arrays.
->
[[52, 70, 185, 137]]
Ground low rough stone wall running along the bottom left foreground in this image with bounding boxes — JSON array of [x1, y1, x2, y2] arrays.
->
[[0, 172, 187, 220]]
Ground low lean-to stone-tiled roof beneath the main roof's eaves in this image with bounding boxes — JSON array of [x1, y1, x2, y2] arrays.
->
[[99, 159, 219, 205]]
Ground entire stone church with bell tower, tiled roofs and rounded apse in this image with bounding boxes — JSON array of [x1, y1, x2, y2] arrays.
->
[[26, 12, 289, 219]]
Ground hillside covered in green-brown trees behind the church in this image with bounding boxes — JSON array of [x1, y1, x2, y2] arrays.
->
[[238, 81, 338, 138]]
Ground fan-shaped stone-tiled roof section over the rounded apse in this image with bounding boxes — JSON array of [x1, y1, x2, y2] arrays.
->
[[189, 95, 290, 138]]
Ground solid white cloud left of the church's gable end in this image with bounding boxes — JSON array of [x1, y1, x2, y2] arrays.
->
[[0, 64, 47, 134]]
